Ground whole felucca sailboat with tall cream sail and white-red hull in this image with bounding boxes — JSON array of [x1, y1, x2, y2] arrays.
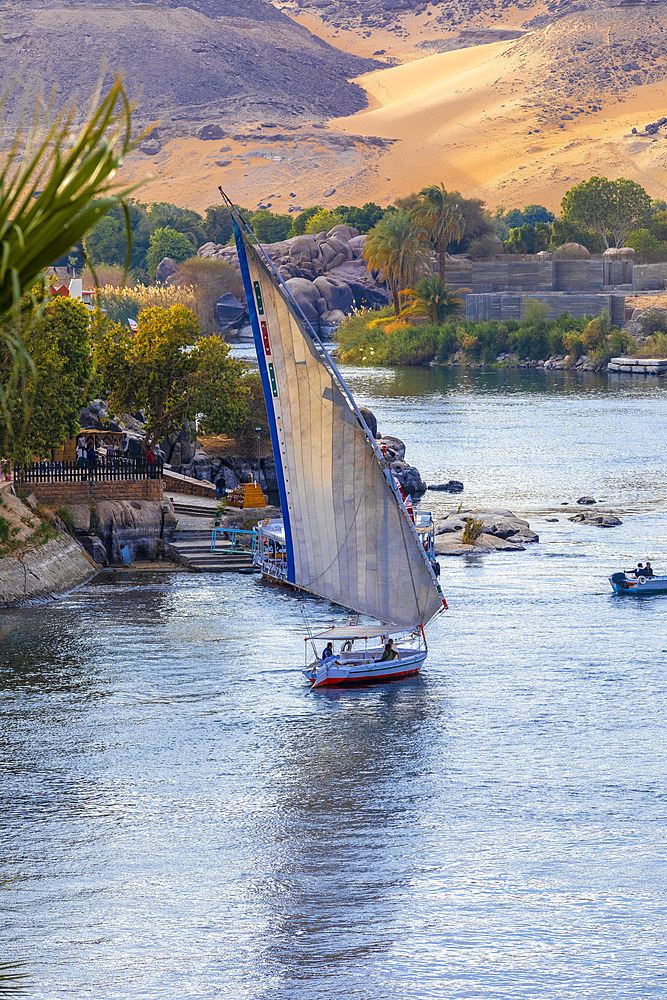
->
[[226, 199, 447, 687]]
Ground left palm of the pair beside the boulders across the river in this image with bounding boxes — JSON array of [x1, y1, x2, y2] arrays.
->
[[364, 211, 428, 316]]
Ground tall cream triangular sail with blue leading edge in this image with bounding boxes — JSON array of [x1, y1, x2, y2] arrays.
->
[[235, 223, 446, 627]]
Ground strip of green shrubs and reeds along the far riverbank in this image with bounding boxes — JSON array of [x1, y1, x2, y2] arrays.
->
[[338, 301, 652, 366]]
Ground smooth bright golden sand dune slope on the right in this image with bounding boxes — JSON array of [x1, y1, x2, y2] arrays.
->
[[338, 36, 667, 207]]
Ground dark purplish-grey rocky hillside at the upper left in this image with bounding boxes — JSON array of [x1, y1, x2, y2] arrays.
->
[[0, 0, 374, 135]]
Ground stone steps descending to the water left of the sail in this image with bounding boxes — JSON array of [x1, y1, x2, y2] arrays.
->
[[167, 495, 257, 574]]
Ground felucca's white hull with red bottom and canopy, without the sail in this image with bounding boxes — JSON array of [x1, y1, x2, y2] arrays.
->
[[303, 625, 428, 691]]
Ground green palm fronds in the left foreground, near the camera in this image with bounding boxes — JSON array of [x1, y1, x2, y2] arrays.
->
[[0, 80, 145, 437]]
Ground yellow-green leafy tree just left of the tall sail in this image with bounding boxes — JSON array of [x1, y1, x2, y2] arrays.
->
[[95, 305, 245, 447]]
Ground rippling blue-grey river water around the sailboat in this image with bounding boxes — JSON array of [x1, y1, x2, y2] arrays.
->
[[0, 368, 667, 1000]]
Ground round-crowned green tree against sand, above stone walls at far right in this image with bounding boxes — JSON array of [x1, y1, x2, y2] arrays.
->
[[561, 177, 651, 248]]
